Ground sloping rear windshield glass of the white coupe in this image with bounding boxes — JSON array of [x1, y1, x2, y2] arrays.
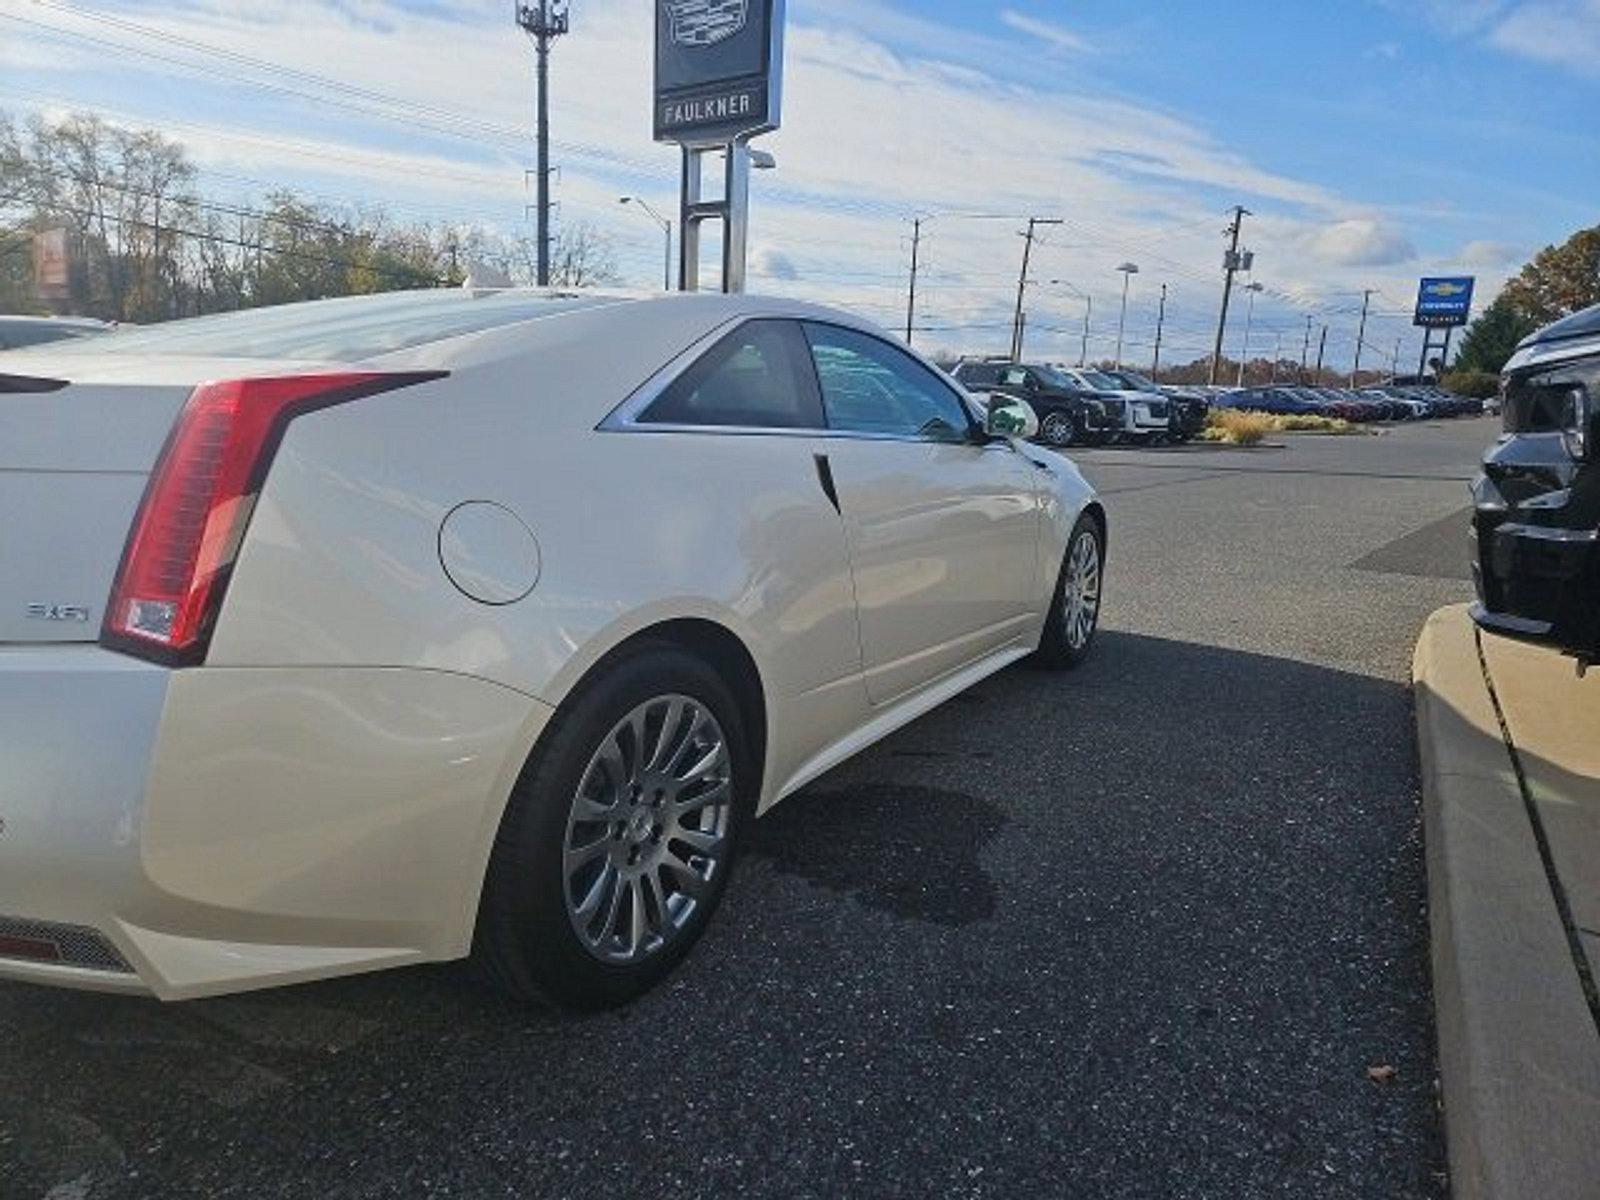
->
[[17, 288, 594, 362]]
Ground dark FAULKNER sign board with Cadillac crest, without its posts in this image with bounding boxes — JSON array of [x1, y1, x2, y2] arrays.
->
[[654, 0, 784, 146]]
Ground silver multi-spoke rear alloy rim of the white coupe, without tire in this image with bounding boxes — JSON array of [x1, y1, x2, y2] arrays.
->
[[562, 694, 734, 965]]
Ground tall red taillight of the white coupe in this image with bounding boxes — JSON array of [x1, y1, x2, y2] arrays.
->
[[101, 371, 445, 666]]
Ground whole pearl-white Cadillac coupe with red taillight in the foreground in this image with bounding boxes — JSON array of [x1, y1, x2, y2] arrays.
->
[[0, 290, 1106, 1006]]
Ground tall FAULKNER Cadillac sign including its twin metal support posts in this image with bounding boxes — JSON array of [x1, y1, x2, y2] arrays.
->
[[654, 0, 784, 291]]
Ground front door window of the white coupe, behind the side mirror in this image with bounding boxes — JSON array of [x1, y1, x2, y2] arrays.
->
[[805, 323, 971, 442]]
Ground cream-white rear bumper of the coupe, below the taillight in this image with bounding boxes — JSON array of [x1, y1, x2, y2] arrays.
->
[[0, 646, 549, 1000]]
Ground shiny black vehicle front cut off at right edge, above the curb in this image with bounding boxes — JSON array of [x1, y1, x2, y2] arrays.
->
[[1472, 304, 1600, 664]]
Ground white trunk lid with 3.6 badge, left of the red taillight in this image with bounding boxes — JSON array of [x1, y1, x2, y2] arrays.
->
[[0, 350, 321, 643]]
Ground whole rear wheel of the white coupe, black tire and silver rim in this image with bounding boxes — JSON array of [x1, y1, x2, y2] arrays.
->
[[472, 643, 757, 1010]]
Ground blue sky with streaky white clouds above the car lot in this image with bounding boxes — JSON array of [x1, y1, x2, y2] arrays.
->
[[0, 0, 1600, 370]]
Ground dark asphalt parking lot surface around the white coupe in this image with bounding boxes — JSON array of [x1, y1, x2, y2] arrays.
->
[[0, 419, 1494, 1200]]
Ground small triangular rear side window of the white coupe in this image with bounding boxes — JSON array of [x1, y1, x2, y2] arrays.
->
[[638, 320, 822, 429]]
